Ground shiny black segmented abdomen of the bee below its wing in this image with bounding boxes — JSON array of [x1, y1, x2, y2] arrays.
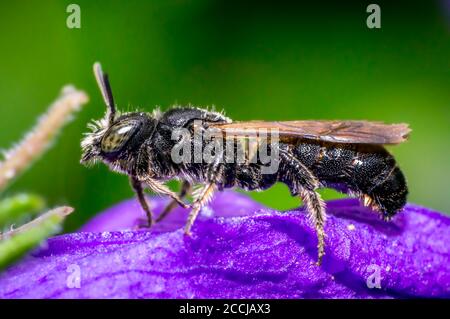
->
[[294, 141, 408, 219]]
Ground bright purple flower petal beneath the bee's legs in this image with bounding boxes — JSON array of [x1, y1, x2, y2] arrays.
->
[[0, 191, 450, 298]]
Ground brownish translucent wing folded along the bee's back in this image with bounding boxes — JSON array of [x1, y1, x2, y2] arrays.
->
[[209, 121, 411, 144]]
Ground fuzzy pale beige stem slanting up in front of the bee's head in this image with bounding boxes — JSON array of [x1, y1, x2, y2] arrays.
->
[[0, 86, 88, 191]]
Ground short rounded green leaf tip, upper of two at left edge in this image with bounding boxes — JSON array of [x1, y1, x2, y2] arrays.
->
[[0, 194, 45, 229]]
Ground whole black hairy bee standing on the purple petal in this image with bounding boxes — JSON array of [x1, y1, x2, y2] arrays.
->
[[81, 63, 410, 264]]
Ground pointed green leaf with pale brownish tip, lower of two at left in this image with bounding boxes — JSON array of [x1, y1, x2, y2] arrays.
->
[[0, 207, 73, 270]]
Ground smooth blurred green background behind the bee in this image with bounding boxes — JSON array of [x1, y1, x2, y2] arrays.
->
[[0, 0, 450, 230]]
